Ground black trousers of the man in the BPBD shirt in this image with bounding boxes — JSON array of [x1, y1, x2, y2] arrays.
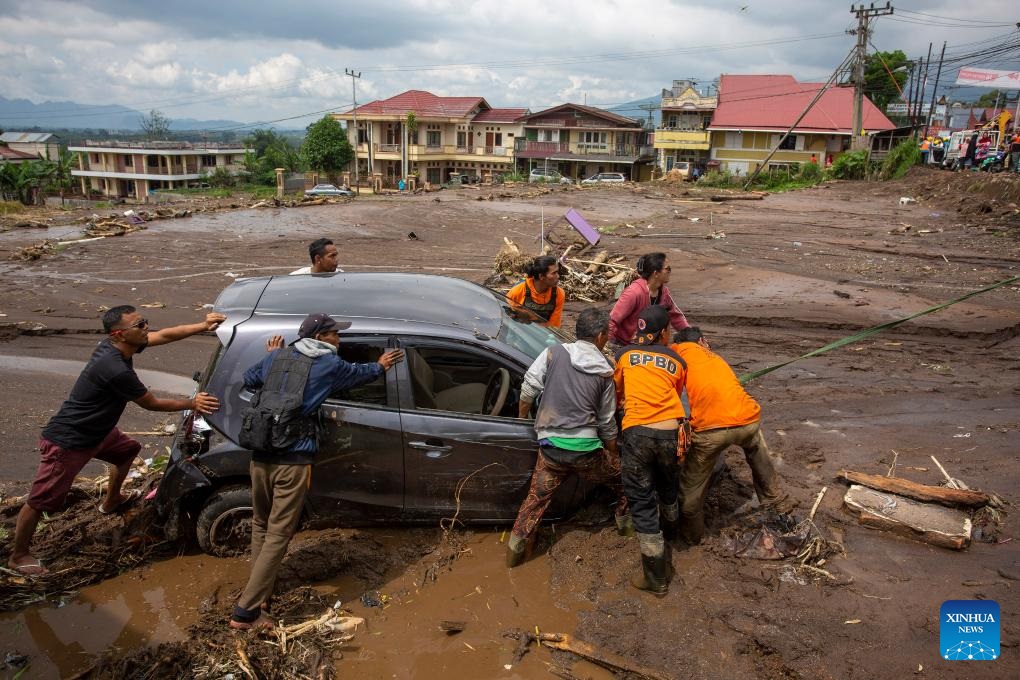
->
[[620, 425, 677, 534]]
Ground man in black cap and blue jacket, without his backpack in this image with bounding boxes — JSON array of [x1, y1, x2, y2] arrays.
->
[[231, 314, 404, 630]]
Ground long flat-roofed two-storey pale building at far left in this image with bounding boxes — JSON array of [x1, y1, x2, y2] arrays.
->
[[68, 140, 251, 202]]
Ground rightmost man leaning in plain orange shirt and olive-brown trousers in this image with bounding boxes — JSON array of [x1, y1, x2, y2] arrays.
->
[[670, 327, 795, 543]]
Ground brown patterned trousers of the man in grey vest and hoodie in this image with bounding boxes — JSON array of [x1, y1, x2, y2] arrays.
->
[[513, 448, 627, 539]]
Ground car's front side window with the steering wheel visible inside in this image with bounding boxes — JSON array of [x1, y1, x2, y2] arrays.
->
[[404, 345, 524, 418]]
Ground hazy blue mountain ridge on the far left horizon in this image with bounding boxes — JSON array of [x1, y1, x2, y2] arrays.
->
[[0, 97, 245, 130]]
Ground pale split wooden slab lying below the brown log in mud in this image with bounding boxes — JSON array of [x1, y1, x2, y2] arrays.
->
[[843, 477, 971, 551]]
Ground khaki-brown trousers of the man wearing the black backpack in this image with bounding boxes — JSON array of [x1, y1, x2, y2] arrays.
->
[[238, 461, 312, 611]]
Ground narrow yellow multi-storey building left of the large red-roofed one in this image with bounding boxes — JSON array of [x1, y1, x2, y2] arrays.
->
[[652, 81, 717, 172]]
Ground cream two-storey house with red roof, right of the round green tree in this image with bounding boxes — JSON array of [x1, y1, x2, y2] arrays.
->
[[334, 90, 527, 187]]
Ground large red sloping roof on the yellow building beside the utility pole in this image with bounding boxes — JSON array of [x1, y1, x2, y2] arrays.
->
[[710, 75, 896, 134]]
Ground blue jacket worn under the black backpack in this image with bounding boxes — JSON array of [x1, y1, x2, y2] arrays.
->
[[245, 347, 386, 465]]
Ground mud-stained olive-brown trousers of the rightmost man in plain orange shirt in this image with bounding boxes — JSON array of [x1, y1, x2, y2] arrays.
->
[[680, 421, 786, 543]]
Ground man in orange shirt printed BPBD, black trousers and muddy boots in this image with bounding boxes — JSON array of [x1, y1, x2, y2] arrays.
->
[[613, 305, 686, 597]]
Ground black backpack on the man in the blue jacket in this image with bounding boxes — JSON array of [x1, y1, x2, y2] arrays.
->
[[238, 350, 318, 453]]
